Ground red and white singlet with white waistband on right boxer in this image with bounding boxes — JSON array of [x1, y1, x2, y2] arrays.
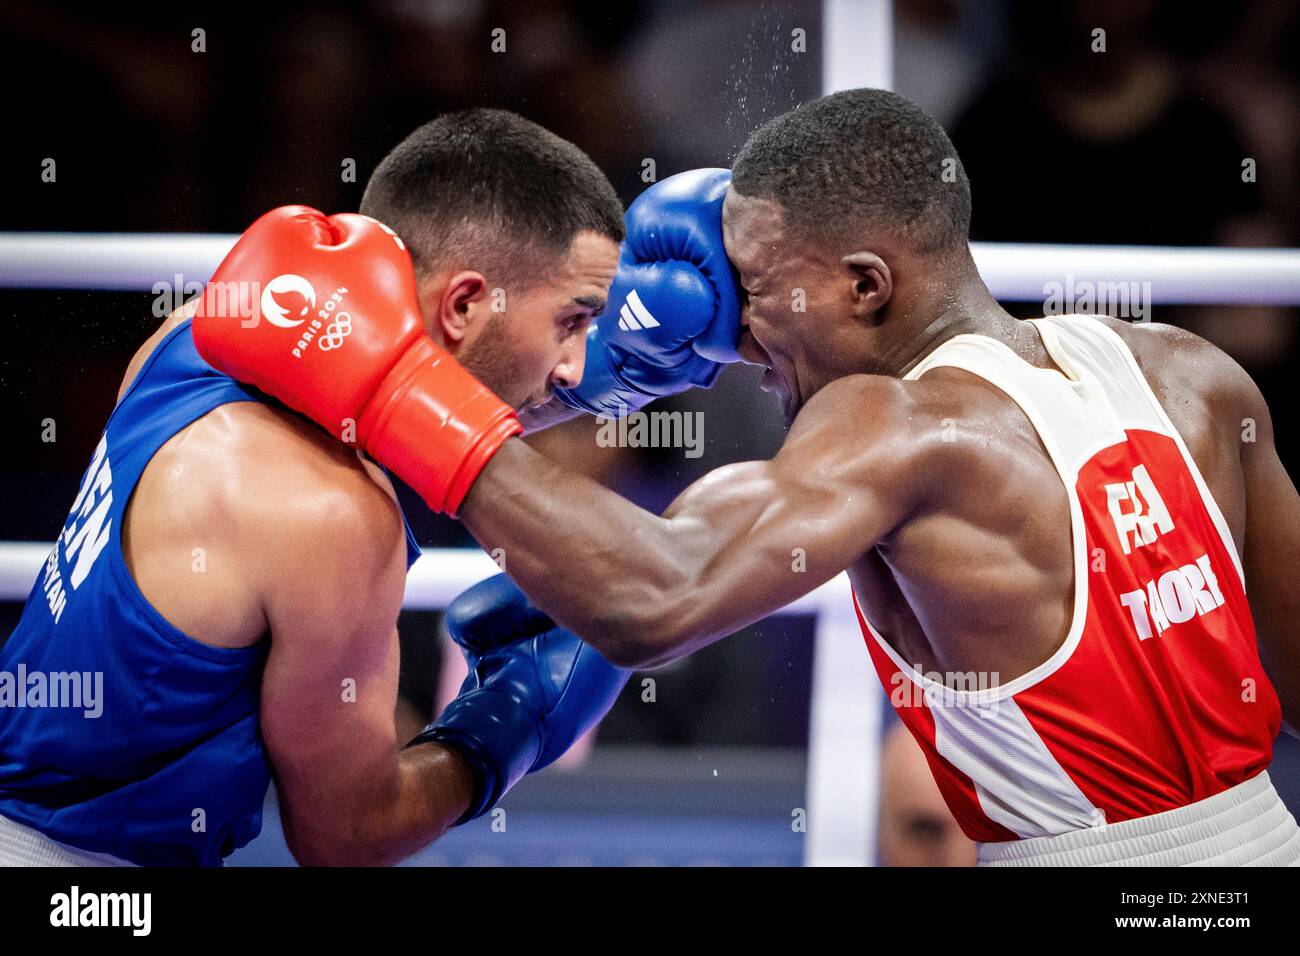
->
[[858, 316, 1300, 864]]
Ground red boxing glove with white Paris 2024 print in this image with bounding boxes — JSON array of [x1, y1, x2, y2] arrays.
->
[[192, 206, 521, 515]]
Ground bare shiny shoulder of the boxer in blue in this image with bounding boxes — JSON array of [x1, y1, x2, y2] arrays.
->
[[129, 402, 406, 646]]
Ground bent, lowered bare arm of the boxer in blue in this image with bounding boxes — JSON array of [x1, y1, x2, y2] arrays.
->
[[261, 452, 473, 865]]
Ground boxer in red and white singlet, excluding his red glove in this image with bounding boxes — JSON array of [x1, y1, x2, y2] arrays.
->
[[447, 90, 1300, 864]]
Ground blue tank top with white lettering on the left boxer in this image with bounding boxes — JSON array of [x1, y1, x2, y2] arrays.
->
[[0, 321, 420, 864]]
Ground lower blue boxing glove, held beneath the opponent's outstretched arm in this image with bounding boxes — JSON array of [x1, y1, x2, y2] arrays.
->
[[411, 574, 632, 823]]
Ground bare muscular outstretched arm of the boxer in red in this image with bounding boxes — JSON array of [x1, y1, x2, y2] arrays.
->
[[460, 376, 926, 666]]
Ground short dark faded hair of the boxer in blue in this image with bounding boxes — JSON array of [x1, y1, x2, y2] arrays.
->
[[361, 109, 625, 287]]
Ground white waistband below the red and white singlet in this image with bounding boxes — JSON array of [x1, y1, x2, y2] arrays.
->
[[978, 771, 1300, 866]]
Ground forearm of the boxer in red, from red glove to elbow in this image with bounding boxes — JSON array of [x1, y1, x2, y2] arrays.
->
[[459, 441, 697, 663]]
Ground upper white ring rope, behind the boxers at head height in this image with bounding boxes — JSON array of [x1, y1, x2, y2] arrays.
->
[[0, 233, 1300, 306]]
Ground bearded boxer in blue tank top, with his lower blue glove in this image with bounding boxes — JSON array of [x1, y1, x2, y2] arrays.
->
[[0, 111, 660, 865]]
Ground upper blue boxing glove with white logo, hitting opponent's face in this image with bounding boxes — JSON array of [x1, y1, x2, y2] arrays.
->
[[556, 169, 740, 418]]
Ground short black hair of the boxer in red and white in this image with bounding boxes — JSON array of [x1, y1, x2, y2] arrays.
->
[[732, 90, 971, 254]]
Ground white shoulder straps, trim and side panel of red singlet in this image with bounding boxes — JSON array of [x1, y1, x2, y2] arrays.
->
[[853, 316, 1258, 842]]
